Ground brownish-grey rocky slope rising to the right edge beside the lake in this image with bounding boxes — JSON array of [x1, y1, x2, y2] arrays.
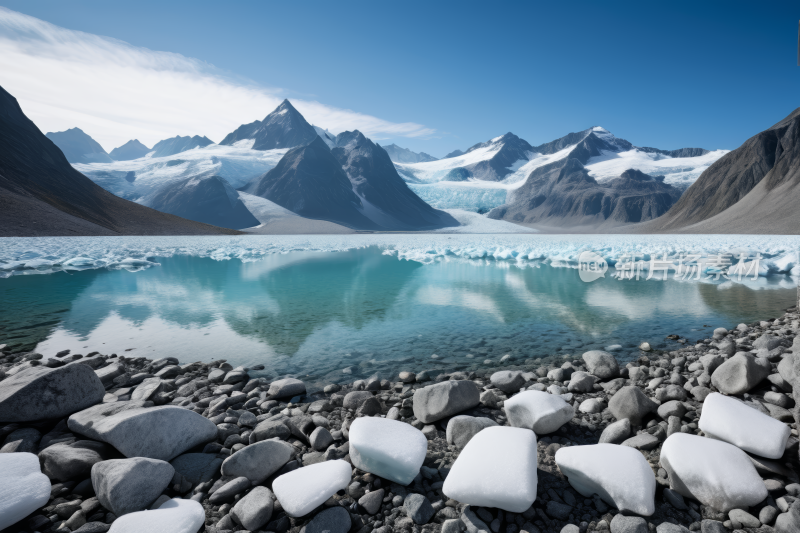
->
[[637, 108, 800, 234]]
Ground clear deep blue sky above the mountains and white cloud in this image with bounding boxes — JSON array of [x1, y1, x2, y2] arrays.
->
[[0, 0, 800, 157]]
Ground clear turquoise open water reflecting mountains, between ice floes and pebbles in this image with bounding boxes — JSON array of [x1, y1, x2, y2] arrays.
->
[[0, 242, 796, 382]]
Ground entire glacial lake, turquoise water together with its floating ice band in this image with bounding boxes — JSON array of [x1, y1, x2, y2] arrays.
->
[[0, 235, 800, 384]]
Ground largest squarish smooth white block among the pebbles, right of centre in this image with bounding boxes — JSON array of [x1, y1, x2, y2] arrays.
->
[[442, 426, 537, 513]]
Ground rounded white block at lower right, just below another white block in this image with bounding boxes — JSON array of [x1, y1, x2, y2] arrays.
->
[[661, 433, 767, 513]]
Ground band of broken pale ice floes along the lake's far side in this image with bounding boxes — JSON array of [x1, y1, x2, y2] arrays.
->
[[0, 235, 800, 280]]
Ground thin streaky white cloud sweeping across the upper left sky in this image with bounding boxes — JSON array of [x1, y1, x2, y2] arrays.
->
[[0, 7, 435, 151]]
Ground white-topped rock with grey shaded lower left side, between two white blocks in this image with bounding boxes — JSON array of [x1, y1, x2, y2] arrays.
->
[[556, 444, 656, 516]]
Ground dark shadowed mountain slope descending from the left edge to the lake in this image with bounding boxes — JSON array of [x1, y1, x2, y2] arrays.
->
[[0, 87, 239, 236]]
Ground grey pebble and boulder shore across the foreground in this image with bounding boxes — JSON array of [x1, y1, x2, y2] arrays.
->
[[0, 308, 800, 533]]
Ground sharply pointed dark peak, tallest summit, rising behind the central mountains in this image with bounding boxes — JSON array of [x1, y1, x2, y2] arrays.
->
[[220, 100, 325, 150]]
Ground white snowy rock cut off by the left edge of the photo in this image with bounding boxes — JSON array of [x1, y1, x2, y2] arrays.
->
[[0, 452, 50, 530]]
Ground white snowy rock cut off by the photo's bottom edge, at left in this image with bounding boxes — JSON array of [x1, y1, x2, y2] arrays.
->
[[108, 498, 206, 533]]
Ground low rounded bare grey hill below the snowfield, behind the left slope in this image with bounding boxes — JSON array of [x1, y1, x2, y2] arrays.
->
[[141, 176, 259, 229]]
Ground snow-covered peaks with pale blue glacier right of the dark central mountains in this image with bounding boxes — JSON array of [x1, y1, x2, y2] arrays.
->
[[395, 127, 727, 213]]
